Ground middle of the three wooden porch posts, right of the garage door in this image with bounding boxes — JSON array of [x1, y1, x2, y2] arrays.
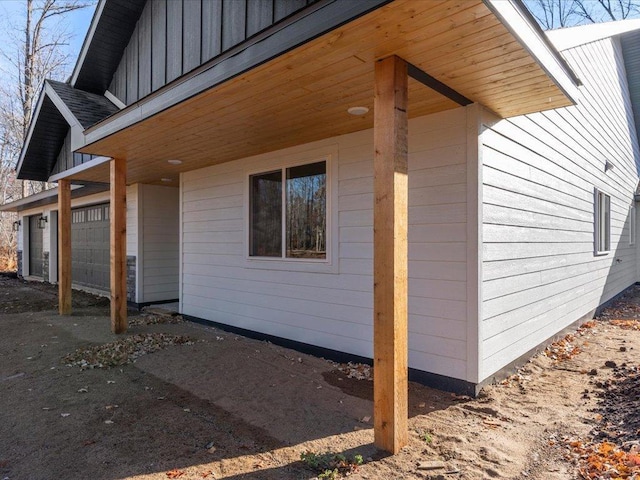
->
[[109, 158, 127, 333]]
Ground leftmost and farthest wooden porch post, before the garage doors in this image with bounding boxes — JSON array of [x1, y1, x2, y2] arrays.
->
[[58, 179, 71, 315]]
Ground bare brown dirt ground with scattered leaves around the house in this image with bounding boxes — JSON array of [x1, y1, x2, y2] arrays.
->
[[0, 275, 640, 480]]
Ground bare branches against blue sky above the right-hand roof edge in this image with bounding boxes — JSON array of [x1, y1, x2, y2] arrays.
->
[[524, 0, 640, 30]]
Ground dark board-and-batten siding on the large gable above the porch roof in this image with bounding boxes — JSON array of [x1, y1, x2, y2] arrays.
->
[[109, 0, 317, 105]]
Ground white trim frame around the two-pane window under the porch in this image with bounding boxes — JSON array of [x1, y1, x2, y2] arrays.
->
[[243, 150, 338, 273]]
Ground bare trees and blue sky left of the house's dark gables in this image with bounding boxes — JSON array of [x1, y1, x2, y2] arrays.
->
[[0, 0, 94, 270]]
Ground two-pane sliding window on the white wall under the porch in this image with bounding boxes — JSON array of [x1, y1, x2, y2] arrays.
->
[[249, 160, 327, 259]]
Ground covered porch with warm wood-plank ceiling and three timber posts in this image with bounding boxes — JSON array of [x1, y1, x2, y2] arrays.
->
[[52, 0, 578, 453]]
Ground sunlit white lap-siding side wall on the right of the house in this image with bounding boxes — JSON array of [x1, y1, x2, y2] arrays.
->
[[481, 39, 638, 378]]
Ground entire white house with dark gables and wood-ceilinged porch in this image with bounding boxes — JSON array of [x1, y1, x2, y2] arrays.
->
[[4, 0, 640, 452]]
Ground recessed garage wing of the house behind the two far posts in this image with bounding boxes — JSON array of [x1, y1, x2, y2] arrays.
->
[[0, 183, 179, 308]]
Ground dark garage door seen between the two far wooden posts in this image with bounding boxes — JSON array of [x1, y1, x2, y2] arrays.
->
[[71, 204, 109, 291]]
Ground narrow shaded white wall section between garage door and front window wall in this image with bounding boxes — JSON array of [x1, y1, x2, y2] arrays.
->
[[138, 185, 180, 303]]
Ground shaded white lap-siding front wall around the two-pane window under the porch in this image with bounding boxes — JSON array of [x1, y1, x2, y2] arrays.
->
[[180, 108, 477, 380]]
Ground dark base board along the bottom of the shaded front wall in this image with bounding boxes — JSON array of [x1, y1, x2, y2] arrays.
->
[[182, 315, 479, 396]]
